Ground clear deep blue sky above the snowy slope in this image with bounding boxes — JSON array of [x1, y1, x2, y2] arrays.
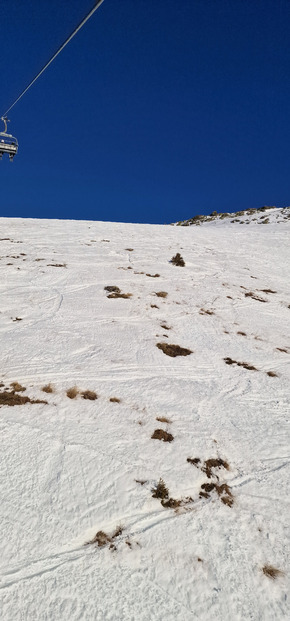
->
[[0, 0, 290, 224]]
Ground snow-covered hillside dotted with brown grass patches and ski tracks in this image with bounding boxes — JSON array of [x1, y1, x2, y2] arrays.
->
[[0, 210, 290, 621]]
